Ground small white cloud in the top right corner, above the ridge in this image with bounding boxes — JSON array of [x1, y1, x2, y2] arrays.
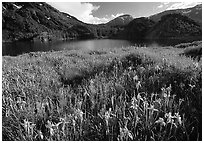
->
[[166, 2, 201, 10]]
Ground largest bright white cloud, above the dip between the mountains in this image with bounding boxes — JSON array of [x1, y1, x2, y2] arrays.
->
[[48, 2, 123, 24]]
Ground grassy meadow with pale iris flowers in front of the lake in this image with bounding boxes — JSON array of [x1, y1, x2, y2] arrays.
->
[[2, 43, 202, 141]]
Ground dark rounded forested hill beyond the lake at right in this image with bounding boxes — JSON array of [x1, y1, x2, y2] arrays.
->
[[146, 13, 202, 40]]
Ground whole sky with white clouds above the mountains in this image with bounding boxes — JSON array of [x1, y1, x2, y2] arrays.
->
[[48, 1, 201, 24]]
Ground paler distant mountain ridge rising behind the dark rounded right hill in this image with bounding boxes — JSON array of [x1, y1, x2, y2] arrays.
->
[[149, 4, 202, 25]]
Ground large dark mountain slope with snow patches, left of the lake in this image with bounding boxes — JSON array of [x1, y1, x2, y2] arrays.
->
[[2, 2, 97, 41]]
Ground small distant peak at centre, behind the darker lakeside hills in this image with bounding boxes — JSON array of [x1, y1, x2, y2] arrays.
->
[[106, 14, 134, 27]]
